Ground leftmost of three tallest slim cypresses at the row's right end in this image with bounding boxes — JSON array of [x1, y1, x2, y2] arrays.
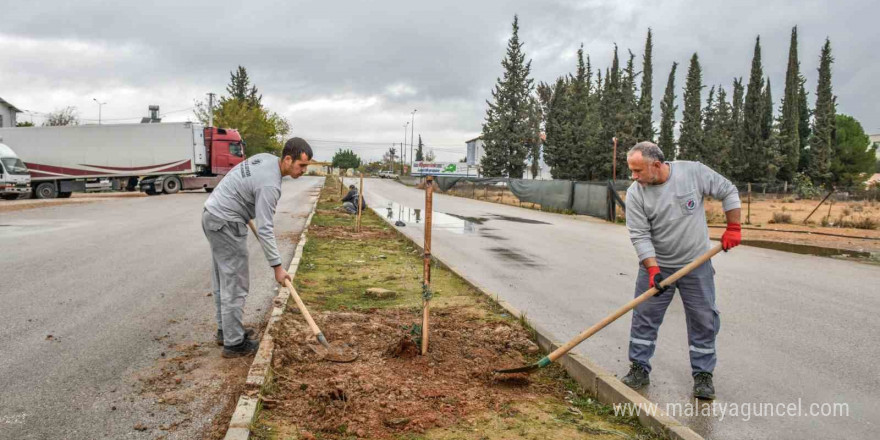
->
[[741, 36, 765, 182]]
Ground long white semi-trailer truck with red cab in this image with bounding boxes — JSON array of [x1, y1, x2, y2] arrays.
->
[[0, 122, 245, 199]]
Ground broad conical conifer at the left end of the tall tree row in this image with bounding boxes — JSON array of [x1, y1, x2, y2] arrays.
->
[[480, 16, 534, 178]]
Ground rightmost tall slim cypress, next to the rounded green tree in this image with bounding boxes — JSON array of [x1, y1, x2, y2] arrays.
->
[[810, 39, 836, 184]]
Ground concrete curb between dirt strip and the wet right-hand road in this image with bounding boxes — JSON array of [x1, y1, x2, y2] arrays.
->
[[373, 204, 703, 440]]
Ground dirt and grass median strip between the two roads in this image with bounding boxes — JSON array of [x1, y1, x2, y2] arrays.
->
[[244, 175, 676, 439]]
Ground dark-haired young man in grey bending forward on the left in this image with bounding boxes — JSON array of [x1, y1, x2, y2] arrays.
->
[[202, 138, 312, 357]]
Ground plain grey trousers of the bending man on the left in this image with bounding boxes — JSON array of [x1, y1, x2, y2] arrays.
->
[[202, 210, 250, 346]]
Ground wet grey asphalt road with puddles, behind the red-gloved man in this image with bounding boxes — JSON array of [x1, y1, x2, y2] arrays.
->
[[354, 179, 880, 439]]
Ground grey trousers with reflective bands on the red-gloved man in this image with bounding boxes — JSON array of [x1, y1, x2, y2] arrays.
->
[[629, 261, 721, 375]]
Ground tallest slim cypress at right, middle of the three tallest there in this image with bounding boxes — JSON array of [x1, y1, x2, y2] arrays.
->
[[779, 26, 802, 182]]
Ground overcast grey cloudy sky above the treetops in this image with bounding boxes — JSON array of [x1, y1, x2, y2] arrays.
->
[[0, 0, 880, 160]]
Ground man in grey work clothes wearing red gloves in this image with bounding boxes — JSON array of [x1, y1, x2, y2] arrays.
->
[[623, 142, 741, 399]]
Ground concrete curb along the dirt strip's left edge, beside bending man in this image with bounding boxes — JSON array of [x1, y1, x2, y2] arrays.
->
[[223, 182, 324, 440]]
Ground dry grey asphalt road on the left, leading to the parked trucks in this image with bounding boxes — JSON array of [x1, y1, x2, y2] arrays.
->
[[0, 177, 322, 440]]
